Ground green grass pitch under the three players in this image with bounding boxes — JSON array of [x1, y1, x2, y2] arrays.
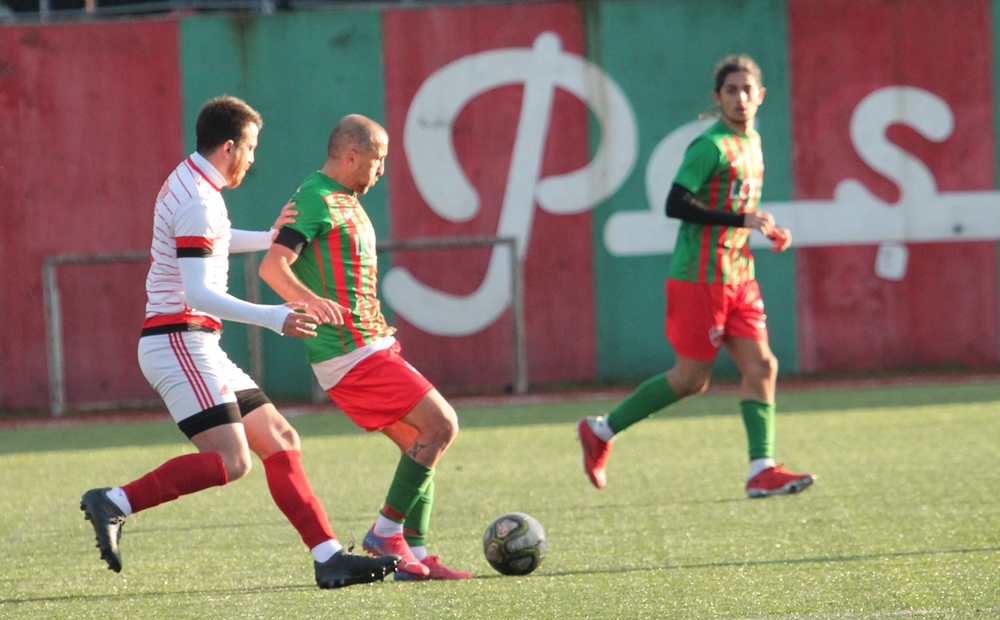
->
[[0, 383, 1000, 620]]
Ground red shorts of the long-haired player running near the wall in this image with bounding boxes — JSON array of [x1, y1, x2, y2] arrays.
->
[[666, 280, 767, 361]]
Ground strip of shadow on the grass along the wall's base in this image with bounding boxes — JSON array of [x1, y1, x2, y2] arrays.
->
[[0, 380, 1000, 455]]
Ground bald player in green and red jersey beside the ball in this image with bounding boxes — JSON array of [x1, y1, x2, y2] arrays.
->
[[260, 114, 472, 581]]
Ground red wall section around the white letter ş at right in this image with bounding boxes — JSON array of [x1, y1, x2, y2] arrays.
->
[[789, 0, 997, 372]]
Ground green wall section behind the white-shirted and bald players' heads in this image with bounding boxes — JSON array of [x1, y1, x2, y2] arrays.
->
[[180, 10, 389, 399]]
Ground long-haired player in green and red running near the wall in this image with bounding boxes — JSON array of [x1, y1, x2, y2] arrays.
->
[[577, 56, 816, 498]]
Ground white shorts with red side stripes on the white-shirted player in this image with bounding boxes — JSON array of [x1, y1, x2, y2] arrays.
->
[[139, 331, 257, 424]]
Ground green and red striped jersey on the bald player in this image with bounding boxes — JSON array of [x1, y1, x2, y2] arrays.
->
[[286, 171, 396, 364]]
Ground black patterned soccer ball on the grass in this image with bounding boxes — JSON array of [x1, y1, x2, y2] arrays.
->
[[483, 512, 545, 575]]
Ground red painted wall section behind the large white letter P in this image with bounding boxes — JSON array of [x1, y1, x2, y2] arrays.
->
[[383, 4, 596, 385]]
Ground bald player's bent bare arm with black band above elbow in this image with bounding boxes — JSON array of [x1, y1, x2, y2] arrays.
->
[[258, 226, 351, 325]]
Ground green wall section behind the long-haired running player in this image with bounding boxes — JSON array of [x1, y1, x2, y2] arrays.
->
[[587, 0, 796, 382]]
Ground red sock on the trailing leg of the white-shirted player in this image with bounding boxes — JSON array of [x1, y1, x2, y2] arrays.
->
[[122, 452, 229, 513]]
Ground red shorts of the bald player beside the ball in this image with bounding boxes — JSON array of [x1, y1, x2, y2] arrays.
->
[[326, 343, 434, 431]]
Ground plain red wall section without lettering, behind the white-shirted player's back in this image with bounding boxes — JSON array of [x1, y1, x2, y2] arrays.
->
[[0, 21, 183, 408]]
